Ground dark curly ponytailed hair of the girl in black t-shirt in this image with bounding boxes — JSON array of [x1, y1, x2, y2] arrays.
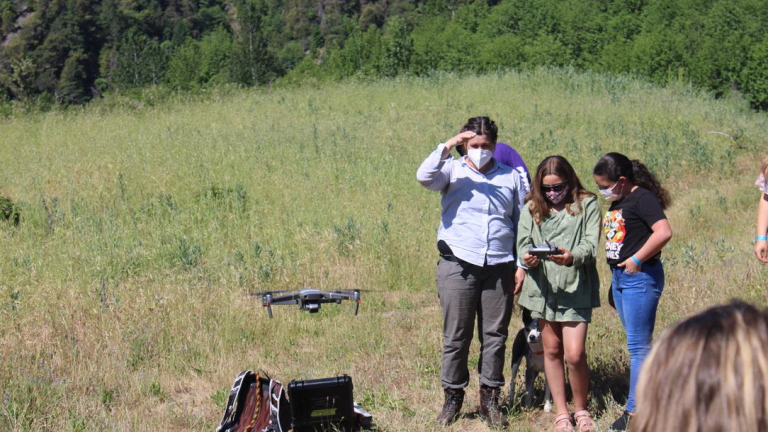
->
[[592, 153, 672, 210]]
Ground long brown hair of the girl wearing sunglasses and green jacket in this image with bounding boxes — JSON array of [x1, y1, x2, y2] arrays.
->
[[525, 156, 595, 225]]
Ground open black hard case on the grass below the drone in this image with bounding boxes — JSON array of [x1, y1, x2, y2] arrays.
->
[[288, 375, 355, 432]]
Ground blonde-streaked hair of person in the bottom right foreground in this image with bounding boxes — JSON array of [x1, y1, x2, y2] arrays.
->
[[630, 301, 768, 432]]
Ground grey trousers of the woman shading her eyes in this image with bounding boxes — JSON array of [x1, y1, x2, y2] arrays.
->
[[437, 259, 516, 389]]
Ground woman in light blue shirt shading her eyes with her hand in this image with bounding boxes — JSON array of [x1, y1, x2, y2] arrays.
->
[[416, 117, 528, 426]]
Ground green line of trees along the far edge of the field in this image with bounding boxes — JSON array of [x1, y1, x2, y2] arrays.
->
[[0, 0, 768, 109]]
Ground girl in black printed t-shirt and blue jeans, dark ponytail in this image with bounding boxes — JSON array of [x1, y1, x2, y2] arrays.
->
[[592, 153, 672, 431]]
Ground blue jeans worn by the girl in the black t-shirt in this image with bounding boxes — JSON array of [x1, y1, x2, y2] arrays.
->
[[612, 261, 664, 413]]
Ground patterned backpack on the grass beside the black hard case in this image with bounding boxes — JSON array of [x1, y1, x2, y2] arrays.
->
[[216, 370, 291, 432]]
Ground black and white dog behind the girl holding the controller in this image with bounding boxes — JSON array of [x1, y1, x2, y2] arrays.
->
[[509, 309, 552, 412]]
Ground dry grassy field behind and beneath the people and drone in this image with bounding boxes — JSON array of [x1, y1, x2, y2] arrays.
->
[[0, 70, 768, 432]]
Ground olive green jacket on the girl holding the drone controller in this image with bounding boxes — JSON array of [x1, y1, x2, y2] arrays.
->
[[517, 196, 600, 313]]
